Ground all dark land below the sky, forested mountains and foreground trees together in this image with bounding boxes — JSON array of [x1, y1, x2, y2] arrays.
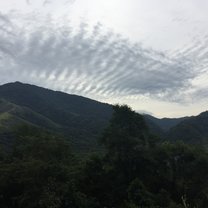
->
[[0, 83, 208, 208]]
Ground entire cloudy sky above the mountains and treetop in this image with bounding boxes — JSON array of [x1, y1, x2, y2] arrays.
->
[[0, 0, 208, 117]]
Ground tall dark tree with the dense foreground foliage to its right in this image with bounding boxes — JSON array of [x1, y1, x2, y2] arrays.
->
[[81, 106, 208, 208]]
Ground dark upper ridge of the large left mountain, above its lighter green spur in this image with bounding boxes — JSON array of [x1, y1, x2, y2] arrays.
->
[[0, 82, 112, 150]]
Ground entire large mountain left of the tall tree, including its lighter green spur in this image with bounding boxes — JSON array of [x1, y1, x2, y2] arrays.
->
[[0, 82, 112, 150]]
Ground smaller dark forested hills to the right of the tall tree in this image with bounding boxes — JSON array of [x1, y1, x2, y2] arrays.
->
[[144, 111, 208, 146]]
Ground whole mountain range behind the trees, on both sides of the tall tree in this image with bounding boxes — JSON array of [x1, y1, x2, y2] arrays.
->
[[0, 82, 208, 148]]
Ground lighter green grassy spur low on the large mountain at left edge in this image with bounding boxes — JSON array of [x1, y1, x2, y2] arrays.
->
[[0, 99, 60, 146]]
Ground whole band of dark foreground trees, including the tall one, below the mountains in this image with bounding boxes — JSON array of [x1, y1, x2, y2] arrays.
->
[[0, 106, 208, 208]]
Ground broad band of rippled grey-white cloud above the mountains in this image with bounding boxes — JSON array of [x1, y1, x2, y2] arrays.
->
[[0, 13, 208, 102]]
